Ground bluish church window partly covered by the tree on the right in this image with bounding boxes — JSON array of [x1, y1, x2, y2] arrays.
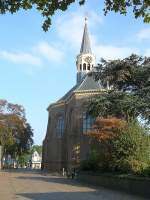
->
[[83, 112, 95, 133]]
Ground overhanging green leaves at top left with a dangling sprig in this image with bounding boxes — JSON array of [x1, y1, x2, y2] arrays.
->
[[0, 0, 84, 31]]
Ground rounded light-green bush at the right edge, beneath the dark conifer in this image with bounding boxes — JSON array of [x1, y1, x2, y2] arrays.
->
[[110, 121, 150, 173]]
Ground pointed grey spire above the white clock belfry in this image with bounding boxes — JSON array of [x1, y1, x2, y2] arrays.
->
[[80, 18, 92, 54]]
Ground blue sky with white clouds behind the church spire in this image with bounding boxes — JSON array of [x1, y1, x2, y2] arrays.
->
[[0, 0, 150, 145]]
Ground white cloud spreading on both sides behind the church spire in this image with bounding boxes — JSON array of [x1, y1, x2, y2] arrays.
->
[[56, 11, 139, 61]]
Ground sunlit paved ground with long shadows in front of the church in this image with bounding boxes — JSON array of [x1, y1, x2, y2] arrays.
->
[[0, 171, 148, 200]]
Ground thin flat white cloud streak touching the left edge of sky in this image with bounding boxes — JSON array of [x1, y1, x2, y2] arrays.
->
[[0, 50, 42, 66]]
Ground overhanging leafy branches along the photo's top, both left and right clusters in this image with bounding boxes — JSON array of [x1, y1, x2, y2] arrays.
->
[[0, 0, 150, 31]]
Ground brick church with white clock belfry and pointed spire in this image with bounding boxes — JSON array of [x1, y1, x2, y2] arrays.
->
[[42, 20, 103, 171]]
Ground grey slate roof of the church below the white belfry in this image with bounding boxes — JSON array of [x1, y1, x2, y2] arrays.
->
[[56, 73, 102, 103]]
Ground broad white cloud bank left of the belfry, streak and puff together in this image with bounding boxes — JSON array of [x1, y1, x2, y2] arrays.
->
[[0, 42, 64, 74]]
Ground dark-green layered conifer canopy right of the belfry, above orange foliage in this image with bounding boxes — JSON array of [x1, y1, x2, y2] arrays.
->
[[89, 55, 150, 123]]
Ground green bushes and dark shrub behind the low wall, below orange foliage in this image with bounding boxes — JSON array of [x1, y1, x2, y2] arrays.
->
[[87, 121, 150, 174]]
